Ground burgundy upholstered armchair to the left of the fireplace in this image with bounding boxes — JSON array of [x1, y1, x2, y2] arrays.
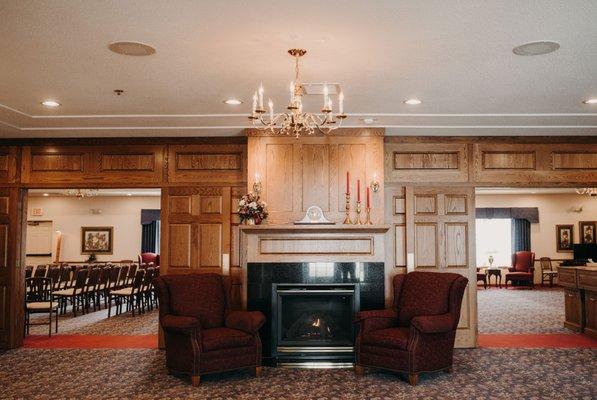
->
[[153, 274, 265, 386]]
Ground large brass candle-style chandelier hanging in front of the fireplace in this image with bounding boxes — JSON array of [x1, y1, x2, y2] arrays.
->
[[249, 49, 347, 138]]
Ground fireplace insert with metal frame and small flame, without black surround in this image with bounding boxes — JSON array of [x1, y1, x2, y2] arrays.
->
[[272, 283, 359, 362]]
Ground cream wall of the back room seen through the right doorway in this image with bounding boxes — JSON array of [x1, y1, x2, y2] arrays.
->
[[476, 194, 597, 282]]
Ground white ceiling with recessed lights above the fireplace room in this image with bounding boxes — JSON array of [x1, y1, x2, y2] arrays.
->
[[0, 0, 597, 137]]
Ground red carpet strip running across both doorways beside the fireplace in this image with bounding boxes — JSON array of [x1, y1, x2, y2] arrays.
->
[[24, 334, 597, 349]]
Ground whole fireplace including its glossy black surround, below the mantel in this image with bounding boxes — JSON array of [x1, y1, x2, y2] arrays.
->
[[247, 262, 384, 366]]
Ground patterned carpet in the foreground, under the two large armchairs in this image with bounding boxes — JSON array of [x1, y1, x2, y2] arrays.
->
[[0, 349, 597, 400]]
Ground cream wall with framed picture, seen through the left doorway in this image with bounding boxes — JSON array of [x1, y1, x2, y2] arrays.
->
[[27, 196, 160, 265]]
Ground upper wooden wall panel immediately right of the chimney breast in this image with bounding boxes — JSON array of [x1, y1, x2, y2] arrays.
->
[[384, 143, 469, 182]]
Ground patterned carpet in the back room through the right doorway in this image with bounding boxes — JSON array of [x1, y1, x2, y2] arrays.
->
[[477, 287, 570, 333]]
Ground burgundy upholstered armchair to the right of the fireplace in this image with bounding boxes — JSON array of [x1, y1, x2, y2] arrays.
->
[[355, 272, 468, 385]]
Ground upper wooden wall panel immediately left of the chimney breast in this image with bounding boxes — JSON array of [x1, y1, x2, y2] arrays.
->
[[168, 144, 247, 185]]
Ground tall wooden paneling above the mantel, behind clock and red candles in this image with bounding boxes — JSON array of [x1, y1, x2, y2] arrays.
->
[[247, 136, 385, 224]]
